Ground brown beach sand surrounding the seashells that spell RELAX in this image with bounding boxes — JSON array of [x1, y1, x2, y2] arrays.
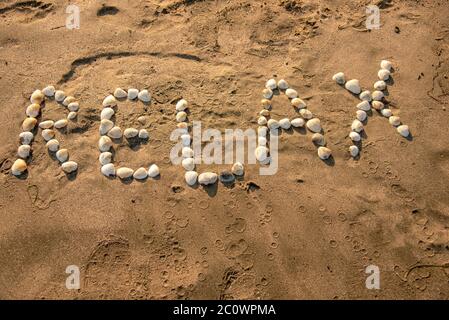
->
[[0, 0, 449, 299]]
